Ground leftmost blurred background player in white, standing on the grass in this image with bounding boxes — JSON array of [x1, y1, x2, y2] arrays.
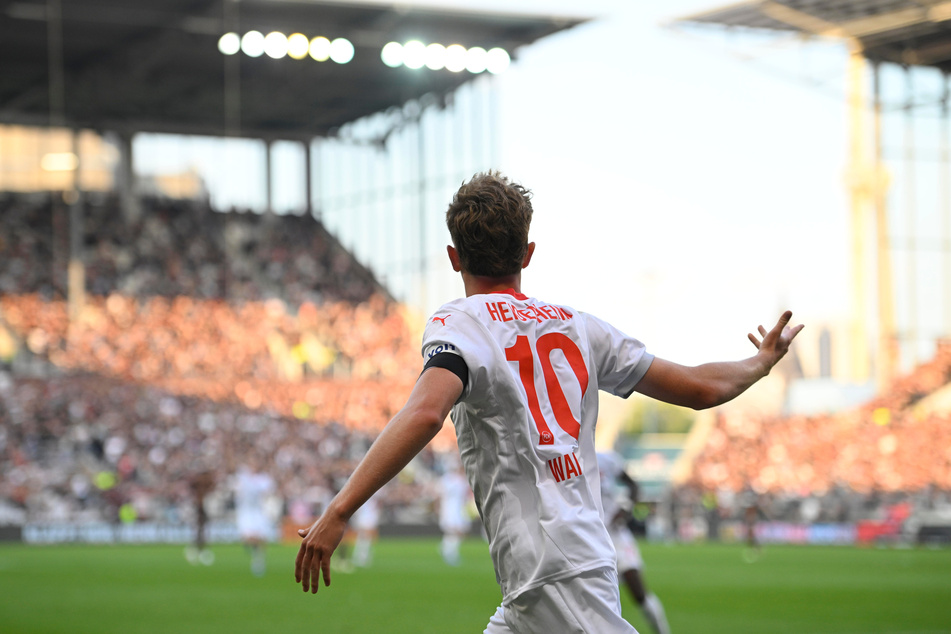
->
[[234, 456, 275, 577]]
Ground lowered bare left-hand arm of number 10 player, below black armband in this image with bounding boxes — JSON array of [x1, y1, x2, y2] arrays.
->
[[294, 368, 463, 593]]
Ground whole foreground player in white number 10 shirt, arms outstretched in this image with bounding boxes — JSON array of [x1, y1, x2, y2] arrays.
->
[[295, 172, 801, 634]]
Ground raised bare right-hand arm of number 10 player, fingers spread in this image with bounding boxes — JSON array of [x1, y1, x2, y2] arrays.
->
[[634, 310, 803, 409]]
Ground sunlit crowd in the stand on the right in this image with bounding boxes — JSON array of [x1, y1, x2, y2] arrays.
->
[[679, 343, 951, 523]]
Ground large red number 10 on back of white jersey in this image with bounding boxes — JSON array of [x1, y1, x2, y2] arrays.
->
[[505, 332, 588, 445]]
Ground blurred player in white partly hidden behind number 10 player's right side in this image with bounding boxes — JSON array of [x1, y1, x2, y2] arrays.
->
[[598, 451, 670, 634]]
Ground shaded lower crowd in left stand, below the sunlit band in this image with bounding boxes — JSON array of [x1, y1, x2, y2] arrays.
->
[[0, 374, 435, 523]]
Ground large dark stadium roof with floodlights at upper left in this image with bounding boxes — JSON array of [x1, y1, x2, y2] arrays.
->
[[0, 0, 585, 138]]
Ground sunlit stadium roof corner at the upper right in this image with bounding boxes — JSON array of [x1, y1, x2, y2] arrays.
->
[[677, 0, 951, 72]]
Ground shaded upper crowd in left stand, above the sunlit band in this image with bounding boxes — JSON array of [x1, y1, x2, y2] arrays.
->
[[0, 194, 384, 306]]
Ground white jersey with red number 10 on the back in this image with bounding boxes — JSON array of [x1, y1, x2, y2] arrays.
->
[[423, 291, 653, 601]]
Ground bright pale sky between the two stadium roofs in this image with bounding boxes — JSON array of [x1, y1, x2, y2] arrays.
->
[[426, 0, 850, 364]]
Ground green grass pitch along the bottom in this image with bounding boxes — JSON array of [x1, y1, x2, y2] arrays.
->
[[0, 539, 951, 634]]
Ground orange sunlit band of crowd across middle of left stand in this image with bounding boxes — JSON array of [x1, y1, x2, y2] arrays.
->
[[0, 293, 420, 389]]
